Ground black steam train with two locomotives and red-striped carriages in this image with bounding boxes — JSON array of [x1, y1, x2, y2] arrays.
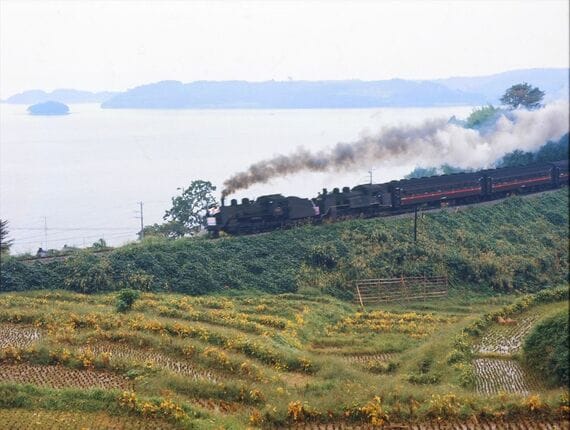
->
[[206, 160, 568, 237]]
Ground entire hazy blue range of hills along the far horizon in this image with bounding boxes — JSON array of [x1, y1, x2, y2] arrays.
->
[[5, 68, 570, 109]]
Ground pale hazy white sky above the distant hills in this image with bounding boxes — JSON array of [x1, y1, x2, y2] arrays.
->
[[0, 0, 570, 98]]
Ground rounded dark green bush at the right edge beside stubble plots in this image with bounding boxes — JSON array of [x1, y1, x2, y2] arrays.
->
[[524, 309, 570, 387]]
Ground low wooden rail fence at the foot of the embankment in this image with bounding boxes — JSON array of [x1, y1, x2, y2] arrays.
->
[[355, 276, 449, 307]]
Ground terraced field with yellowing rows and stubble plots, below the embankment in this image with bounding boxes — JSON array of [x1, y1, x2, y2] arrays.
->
[[0, 292, 570, 430]]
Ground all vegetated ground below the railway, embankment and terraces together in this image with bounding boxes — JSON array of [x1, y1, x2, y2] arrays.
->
[[0, 190, 570, 429]]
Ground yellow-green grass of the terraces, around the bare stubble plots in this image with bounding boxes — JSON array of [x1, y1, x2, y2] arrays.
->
[[0, 290, 563, 428]]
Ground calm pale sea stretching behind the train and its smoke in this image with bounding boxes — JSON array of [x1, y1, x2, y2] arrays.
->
[[0, 103, 472, 254]]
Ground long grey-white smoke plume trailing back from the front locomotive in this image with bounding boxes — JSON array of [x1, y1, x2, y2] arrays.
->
[[222, 102, 569, 197]]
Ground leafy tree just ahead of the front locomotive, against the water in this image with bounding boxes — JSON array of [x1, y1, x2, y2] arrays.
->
[[163, 180, 216, 237]]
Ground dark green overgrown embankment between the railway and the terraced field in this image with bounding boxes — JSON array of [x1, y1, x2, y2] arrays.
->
[[1, 188, 568, 298]]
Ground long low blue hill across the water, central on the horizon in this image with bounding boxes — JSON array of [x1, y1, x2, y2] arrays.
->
[[102, 79, 480, 109]]
